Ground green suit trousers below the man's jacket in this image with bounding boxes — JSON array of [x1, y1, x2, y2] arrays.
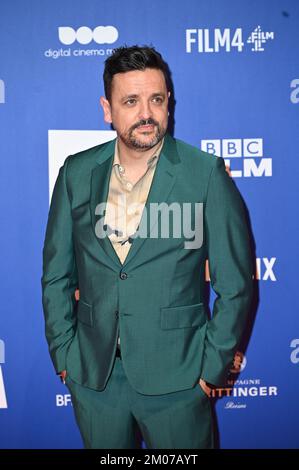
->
[[66, 357, 213, 449]]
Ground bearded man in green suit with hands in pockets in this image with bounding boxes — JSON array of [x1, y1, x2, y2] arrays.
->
[[42, 46, 253, 449]]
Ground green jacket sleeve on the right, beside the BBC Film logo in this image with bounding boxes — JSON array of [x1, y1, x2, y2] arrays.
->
[[201, 157, 254, 386]]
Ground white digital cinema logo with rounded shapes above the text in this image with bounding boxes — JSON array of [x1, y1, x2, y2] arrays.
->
[[44, 26, 119, 59]]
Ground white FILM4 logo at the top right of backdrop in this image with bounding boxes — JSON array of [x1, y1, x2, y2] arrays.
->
[[185, 26, 274, 54]]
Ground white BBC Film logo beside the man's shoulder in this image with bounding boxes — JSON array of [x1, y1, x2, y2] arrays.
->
[[201, 138, 272, 178]]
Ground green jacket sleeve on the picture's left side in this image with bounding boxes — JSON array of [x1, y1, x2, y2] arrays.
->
[[41, 157, 78, 373]]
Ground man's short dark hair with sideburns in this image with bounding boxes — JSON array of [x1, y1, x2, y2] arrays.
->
[[103, 45, 170, 101]]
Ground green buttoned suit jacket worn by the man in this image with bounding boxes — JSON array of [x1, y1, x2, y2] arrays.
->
[[42, 134, 253, 395]]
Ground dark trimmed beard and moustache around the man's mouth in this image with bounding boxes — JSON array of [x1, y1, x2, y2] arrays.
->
[[119, 118, 166, 152]]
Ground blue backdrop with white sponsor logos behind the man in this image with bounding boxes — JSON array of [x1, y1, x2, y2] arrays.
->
[[0, 0, 299, 449]]
